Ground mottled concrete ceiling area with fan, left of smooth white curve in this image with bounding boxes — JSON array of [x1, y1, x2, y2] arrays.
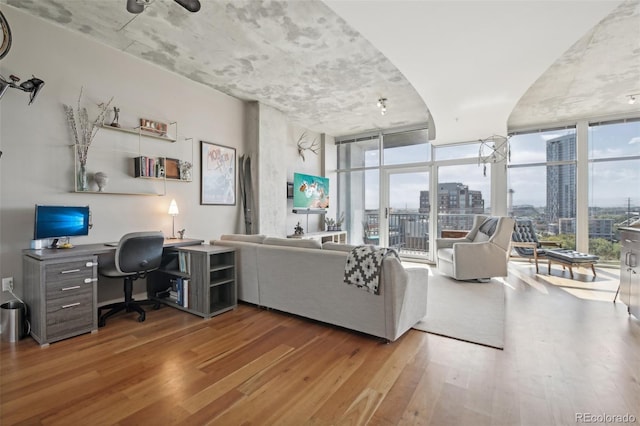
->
[[7, 0, 428, 136]]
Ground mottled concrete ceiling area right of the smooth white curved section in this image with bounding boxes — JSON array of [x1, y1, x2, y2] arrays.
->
[[509, 0, 640, 128]]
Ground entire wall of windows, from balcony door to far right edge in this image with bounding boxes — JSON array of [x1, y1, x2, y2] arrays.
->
[[336, 118, 640, 264]]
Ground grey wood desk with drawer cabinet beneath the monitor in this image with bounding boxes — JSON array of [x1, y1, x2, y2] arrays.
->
[[22, 239, 203, 345]]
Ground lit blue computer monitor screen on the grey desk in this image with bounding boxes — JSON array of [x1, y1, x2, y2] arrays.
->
[[33, 205, 89, 240]]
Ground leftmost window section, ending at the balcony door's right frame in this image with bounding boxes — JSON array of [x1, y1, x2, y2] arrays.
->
[[336, 127, 431, 257]]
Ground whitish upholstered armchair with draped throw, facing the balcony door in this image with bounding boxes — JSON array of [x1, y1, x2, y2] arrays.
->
[[436, 215, 514, 280]]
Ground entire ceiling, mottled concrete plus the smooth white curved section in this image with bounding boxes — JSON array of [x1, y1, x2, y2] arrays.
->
[[6, 0, 640, 143]]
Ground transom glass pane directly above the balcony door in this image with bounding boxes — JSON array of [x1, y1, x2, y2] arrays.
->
[[382, 129, 431, 165]]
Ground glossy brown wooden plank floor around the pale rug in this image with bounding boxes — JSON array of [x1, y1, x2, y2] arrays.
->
[[0, 262, 640, 426]]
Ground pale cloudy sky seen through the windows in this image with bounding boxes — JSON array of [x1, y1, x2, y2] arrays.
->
[[358, 121, 640, 209]]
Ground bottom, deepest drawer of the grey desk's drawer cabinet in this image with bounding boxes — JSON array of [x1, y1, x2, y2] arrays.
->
[[47, 287, 97, 339]]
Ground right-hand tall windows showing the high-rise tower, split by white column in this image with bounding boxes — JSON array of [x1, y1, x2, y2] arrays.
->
[[508, 120, 640, 264]]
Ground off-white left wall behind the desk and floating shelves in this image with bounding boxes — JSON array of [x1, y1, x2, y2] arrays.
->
[[0, 5, 246, 298]]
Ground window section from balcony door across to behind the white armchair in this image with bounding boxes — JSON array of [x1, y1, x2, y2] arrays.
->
[[336, 128, 503, 259]]
